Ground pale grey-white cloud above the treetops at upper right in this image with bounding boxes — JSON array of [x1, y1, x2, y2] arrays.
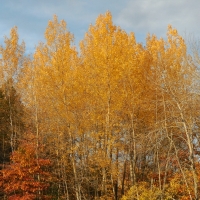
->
[[116, 0, 200, 40]]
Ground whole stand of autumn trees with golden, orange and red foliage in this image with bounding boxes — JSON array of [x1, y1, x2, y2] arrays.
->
[[0, 12, 200, 200]]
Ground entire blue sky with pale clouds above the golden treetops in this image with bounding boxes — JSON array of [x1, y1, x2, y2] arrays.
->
[[0, 0, 200, 53]]
